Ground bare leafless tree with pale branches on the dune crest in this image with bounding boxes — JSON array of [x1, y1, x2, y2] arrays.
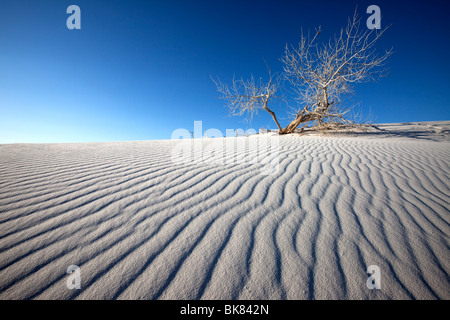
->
[[215, 10, 392, 134]]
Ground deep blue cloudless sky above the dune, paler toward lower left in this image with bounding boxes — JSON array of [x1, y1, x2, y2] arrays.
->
[[0, 0, 450, 143]]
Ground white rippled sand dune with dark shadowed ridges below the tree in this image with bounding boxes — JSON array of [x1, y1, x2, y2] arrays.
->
[[0, 122, 450, 299]]
